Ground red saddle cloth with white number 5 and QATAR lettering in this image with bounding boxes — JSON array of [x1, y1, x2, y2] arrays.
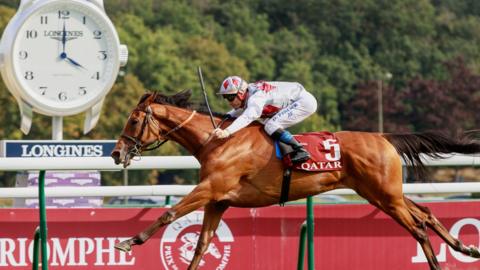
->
[[275, 131, 342, 172]]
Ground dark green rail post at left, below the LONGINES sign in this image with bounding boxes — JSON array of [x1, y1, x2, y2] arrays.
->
[[32, 170, 48, 270]]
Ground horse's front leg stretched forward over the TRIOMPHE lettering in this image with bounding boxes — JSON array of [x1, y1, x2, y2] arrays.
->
[[115, 181, 212, 252]]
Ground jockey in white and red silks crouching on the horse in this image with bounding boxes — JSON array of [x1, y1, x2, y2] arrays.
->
[[213, 76, 317, 163]]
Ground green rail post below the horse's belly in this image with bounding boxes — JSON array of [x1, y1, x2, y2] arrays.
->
[[297, 197, 315, 270]]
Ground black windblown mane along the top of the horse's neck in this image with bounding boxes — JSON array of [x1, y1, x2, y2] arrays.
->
[[138, 89, 226, 118]]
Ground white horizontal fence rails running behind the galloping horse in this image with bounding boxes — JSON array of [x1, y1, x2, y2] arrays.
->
[[0, 155, 480, 198]]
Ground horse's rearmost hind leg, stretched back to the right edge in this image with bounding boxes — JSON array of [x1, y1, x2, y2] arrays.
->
[[404, 197, 480, 258]]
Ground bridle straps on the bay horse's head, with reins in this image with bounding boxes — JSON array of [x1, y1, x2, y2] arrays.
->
[[120, 105, 197, 157]]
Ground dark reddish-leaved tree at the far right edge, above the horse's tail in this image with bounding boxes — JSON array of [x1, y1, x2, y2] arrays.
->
[[406, 58, 480, 134]]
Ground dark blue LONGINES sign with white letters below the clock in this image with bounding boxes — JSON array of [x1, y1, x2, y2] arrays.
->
[[0, 140, 116, 158]]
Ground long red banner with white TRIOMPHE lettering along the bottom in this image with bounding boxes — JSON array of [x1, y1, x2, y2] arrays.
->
[[0, 202, 480, 270]]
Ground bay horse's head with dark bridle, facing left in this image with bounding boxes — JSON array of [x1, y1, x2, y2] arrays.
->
[[111, 90, 191, 167]]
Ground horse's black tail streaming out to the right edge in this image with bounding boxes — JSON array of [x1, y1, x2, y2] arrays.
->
[[383, 132, 480, 180]]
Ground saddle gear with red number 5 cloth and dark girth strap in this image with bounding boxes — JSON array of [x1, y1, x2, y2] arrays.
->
[[275, 131, 342, 206]]
